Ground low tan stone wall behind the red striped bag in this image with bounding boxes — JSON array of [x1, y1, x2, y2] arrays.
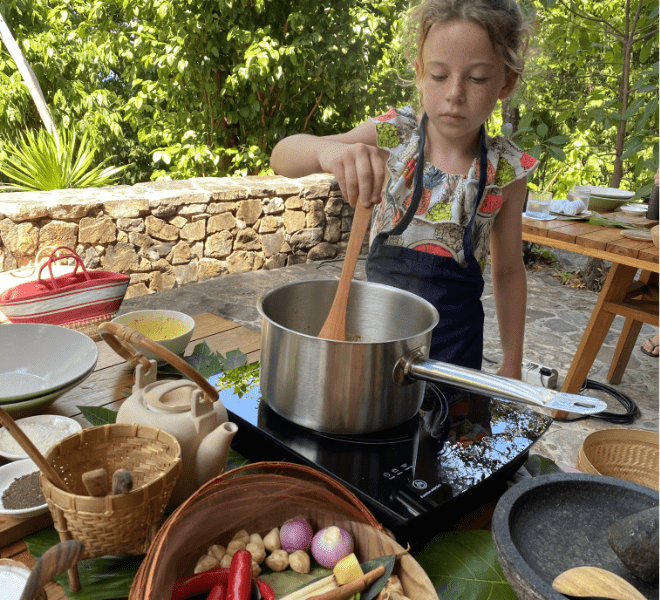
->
[[0, 175, 353, 298]]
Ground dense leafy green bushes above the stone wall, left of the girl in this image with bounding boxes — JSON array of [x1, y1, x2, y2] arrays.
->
[[0, 0, 412, 183]]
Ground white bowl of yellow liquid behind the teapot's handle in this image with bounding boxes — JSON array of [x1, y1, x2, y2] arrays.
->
[[112, 310, 195, 365]]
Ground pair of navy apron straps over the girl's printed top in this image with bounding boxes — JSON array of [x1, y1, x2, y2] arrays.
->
[[377, 113, 488, 262]]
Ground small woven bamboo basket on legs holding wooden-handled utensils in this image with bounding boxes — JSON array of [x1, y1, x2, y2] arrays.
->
[[40, 424, 181, 568]]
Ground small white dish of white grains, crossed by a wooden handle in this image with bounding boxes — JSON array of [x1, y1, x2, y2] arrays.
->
[[0, 415, 82, 460]]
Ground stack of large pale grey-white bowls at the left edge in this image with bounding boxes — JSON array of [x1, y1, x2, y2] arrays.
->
[[0, 323, 99, 419]]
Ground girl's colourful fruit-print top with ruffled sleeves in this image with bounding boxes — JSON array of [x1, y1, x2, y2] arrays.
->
[[370, 106, 539, 272]]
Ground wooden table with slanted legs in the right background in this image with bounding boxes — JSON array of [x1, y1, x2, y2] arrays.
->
[[523, 213, 660, 418]]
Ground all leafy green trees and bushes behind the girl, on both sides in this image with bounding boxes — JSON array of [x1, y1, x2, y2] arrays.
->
[[0, 0, 660, 197]]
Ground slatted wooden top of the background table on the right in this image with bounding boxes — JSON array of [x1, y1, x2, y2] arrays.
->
[[523, 213, 660, 273]]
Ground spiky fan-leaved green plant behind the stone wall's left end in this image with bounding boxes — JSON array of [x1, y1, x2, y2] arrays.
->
[[0, 129, 126, 191]]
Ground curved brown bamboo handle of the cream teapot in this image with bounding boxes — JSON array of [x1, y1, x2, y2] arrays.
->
[[98, 321, 218, 402]]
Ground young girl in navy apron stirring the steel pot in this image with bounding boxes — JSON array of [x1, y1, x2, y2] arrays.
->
[[271, 0, 537, 379]]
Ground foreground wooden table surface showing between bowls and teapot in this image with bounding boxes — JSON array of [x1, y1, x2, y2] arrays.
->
[[0, 313, 261, 600]]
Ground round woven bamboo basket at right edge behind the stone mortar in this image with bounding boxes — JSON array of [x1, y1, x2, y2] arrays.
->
[[576, 429, 660, 491]]
